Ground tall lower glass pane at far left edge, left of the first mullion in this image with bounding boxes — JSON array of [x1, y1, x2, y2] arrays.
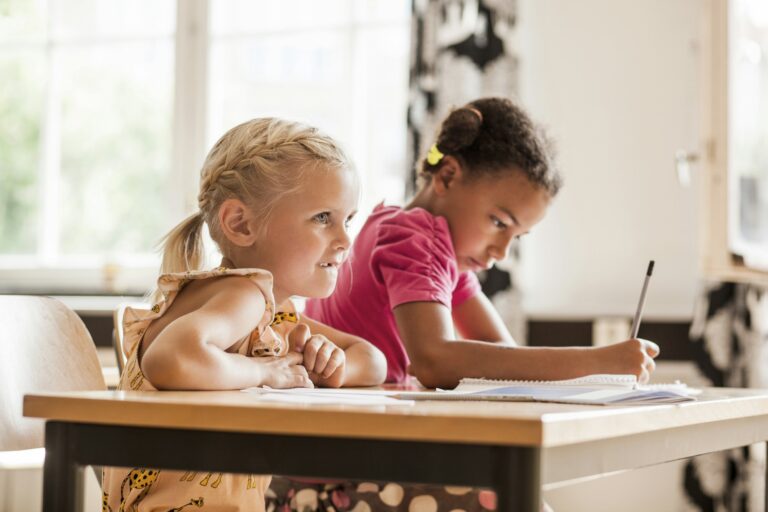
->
[[0, 50, 45, 254]]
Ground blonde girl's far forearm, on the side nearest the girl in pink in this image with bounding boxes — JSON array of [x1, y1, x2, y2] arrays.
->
[[301, 316, 387, 386]]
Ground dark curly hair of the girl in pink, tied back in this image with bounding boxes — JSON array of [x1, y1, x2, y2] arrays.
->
[[420, 98, 563, 197]]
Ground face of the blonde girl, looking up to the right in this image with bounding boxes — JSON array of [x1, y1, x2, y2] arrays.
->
[[249, 168, 360, 302]]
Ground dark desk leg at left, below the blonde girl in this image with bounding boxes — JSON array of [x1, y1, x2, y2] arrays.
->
[[43, 421, 83, 512]]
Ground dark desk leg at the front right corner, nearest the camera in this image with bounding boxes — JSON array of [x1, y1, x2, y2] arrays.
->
[[494, 447, 541, 512]]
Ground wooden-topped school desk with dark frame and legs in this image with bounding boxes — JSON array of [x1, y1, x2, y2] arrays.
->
[[24, 389, 768, 512]]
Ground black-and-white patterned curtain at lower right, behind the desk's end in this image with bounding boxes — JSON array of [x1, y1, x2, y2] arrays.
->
[[684, 283, 768, 512]]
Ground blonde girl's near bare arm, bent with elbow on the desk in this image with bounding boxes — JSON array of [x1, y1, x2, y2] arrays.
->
[[141, 277, 312, 390]]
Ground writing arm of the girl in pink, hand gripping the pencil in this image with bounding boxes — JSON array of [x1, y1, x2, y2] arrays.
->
[[394, 302, 658, 388]]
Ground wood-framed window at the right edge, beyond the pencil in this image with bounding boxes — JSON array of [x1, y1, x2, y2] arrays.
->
[[701, 0, 768, 284]]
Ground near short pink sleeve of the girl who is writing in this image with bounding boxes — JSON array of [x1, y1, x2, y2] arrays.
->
[[371, 209, 459, 309]]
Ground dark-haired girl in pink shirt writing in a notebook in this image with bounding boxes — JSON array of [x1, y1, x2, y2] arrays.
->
[[277, 98, 659, 511]]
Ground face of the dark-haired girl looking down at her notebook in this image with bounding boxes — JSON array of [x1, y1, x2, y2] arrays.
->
[[435, 167, 551, 272]]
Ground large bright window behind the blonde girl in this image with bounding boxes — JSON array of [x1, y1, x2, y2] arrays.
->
[[0, 0, 410, 293]]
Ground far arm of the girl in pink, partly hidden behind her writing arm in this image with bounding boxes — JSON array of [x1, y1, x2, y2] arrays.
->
[[451, 292, 516, 346]]
